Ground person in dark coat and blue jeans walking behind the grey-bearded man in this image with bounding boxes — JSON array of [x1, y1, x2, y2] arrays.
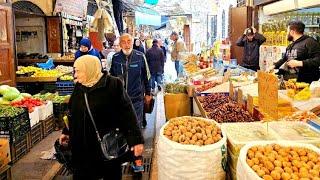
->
[[146, 39, 164, 91]]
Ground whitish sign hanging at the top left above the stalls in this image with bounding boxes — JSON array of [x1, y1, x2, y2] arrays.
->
[[54, 0, 88, 18]]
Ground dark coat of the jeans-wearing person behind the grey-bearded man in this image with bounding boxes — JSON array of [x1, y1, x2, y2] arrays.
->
[[146, 45, 165, 75]]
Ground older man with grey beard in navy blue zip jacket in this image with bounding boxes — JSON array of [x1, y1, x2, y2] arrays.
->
[[110, 33, 151, 128]]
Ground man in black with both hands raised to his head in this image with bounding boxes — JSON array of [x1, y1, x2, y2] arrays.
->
[[236, 27, 266, 71]]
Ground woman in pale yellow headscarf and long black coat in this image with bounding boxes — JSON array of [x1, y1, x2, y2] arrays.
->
[[59, 55, 144, 180]]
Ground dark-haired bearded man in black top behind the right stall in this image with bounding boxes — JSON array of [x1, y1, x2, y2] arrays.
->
[[274, 21, 320, 83]]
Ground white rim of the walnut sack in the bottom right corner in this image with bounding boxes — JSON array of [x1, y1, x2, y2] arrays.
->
[[237, 141, 320, 180]]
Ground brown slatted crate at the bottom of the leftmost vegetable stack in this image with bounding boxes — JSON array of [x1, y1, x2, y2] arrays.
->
[[10, 132, 31, 163]]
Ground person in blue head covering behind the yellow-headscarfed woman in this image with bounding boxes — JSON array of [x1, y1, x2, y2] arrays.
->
[[74, 38, 101, 60]]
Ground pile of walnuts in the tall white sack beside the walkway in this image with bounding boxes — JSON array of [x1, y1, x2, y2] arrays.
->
[[163, 116, 222, 146]]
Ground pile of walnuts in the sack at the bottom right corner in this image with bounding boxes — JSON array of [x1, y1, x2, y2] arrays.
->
[[247, 144, 320, 180]]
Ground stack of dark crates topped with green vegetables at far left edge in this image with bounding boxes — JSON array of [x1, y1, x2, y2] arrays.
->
[[0, 106, 31, 163]]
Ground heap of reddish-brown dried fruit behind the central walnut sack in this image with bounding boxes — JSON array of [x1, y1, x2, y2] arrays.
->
[[198, 93, 255, 123]]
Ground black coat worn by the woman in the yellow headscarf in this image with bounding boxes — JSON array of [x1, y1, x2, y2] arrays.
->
[[63, 75, 144, 174]]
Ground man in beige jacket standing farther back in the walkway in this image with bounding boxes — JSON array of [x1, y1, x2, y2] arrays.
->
[[170, 32, 186, 75]]
